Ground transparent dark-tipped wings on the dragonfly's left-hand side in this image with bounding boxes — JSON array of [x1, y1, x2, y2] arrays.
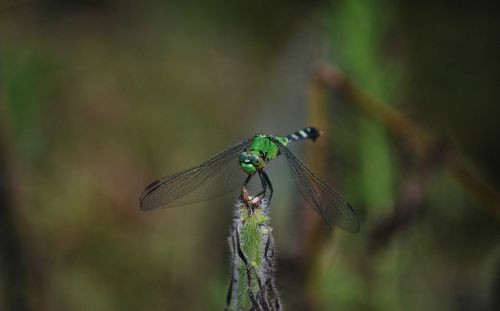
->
[[140, 139, 250, 210]]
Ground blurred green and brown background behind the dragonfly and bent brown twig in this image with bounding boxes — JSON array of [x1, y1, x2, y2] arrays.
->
[[0, 0, 500, 310]]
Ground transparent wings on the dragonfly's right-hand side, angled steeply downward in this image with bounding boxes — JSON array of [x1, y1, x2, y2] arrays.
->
[[272, 139, 359, 233]]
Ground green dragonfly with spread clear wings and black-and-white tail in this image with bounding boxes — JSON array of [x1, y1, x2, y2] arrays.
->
[[140, 127, 360, 233]]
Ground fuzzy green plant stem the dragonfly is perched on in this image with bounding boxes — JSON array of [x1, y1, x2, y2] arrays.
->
[[226, 188, 282, 310]]
